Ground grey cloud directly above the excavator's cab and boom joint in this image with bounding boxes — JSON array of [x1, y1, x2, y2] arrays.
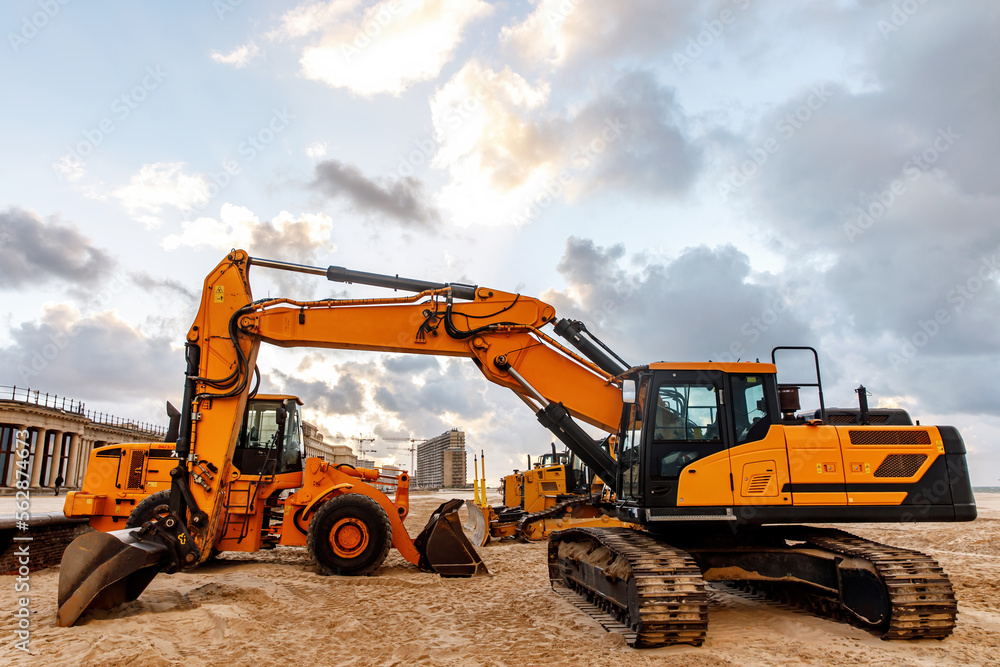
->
[[543, 237, 812, 364]]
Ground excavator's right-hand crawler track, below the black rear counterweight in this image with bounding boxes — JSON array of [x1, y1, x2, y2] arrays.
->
[[740, 528, 958, 640]]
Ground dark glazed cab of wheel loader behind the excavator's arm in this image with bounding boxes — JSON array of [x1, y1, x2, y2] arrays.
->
[[233, 394, 305, 476]]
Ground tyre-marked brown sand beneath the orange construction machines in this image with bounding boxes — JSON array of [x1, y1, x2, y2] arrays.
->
[[0, 493, 1000, 667]]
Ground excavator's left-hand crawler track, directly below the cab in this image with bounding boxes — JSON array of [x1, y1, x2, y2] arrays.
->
[[549, 528, 708, 648]]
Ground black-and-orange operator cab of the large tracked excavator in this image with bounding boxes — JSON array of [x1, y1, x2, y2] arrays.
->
[[616, 363, 779, 508]]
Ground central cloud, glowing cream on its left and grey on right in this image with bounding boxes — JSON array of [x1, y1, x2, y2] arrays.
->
[[431, 65, 701, 225]]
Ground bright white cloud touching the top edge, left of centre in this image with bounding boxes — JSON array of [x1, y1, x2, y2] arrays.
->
[[290, 0, 491, 97]]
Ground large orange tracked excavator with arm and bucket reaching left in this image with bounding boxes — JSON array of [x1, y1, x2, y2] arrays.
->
[[59, 251, 976, 647]]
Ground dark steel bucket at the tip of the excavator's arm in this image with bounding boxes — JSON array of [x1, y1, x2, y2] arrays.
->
[[58, 529, 169, 627]]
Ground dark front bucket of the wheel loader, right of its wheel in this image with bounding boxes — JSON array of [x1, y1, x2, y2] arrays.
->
[[413, 499, 489, 577]]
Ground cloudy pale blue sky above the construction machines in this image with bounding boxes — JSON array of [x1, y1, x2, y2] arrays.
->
[[0, 0, 1000, 486]]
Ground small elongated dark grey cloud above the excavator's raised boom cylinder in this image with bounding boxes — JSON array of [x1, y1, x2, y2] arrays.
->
[[312, 160, 438, 226]]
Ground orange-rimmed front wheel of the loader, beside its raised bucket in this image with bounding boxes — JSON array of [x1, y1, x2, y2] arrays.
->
[[306, 493, 392, 576]]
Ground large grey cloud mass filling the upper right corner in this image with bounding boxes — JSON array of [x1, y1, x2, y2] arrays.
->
[[719, 2, 1000, 363]]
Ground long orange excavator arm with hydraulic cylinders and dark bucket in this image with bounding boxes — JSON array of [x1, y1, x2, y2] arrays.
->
[[59, 250, 622, 625]]
